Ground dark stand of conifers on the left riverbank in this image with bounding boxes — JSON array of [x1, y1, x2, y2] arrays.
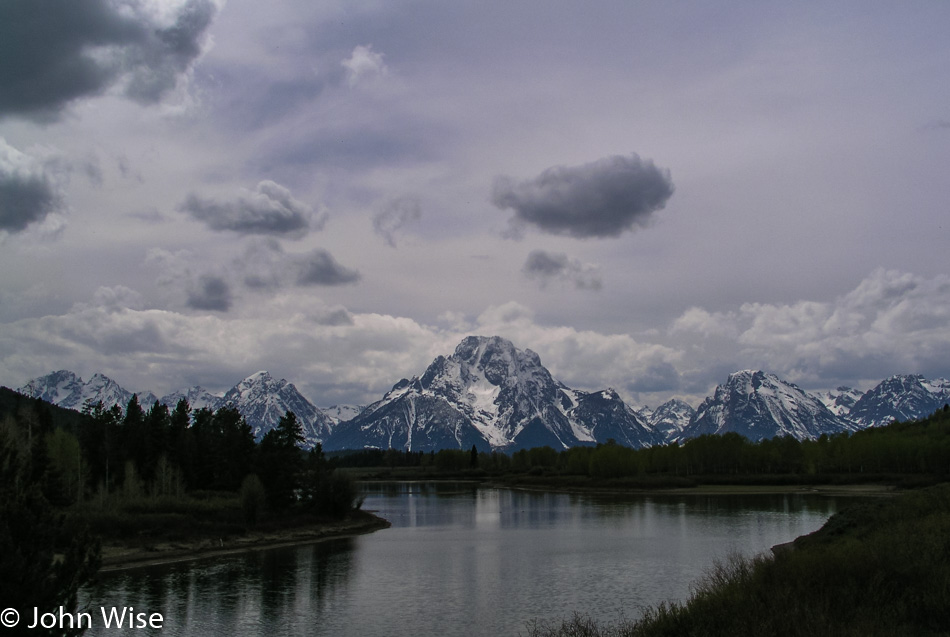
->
[[3, 396, 357, 520]]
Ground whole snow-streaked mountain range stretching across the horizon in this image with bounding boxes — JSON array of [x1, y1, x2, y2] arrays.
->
[[18, 336, 950, 451]]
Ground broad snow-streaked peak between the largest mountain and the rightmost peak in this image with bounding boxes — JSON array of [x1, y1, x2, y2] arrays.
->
[[682, 370, 855, 441]]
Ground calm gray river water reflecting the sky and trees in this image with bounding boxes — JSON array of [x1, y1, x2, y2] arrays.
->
[[84, 483, 856, 637]]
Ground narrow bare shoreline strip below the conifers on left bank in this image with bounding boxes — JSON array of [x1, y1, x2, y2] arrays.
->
[[99, 511, 391, 573]]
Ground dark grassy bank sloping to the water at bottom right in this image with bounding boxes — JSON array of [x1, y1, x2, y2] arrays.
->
[[529, 485, 950, 637]]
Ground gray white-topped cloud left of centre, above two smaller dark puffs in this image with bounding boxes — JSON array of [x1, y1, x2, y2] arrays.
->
[[178, 181, 324, 236]]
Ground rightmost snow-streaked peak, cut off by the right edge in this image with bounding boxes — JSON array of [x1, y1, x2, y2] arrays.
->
[[848, 375, 950, 427]]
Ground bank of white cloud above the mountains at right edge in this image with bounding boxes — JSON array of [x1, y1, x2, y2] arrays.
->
[[670, 269, 950, 386]]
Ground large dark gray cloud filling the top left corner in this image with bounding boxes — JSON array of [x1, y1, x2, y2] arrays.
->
[[0, 0, 217, 121]]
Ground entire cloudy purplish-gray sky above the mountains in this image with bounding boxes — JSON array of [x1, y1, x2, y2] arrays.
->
[[0, 0, 950, 406]]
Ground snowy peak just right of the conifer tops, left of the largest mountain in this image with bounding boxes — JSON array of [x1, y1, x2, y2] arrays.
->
[[221, 371, 333, 449]]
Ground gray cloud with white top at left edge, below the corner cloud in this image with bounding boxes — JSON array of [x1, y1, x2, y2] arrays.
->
[[0, 137, 63, 232]]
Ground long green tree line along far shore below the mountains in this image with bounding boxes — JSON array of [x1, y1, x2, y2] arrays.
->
[[333, 406, 950, 480]]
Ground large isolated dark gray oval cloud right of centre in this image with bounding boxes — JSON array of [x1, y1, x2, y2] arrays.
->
[[492, 154, 673, 239]]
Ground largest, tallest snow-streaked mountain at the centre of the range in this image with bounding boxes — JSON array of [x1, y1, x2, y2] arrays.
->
[[326, 336, 659, 451]]
